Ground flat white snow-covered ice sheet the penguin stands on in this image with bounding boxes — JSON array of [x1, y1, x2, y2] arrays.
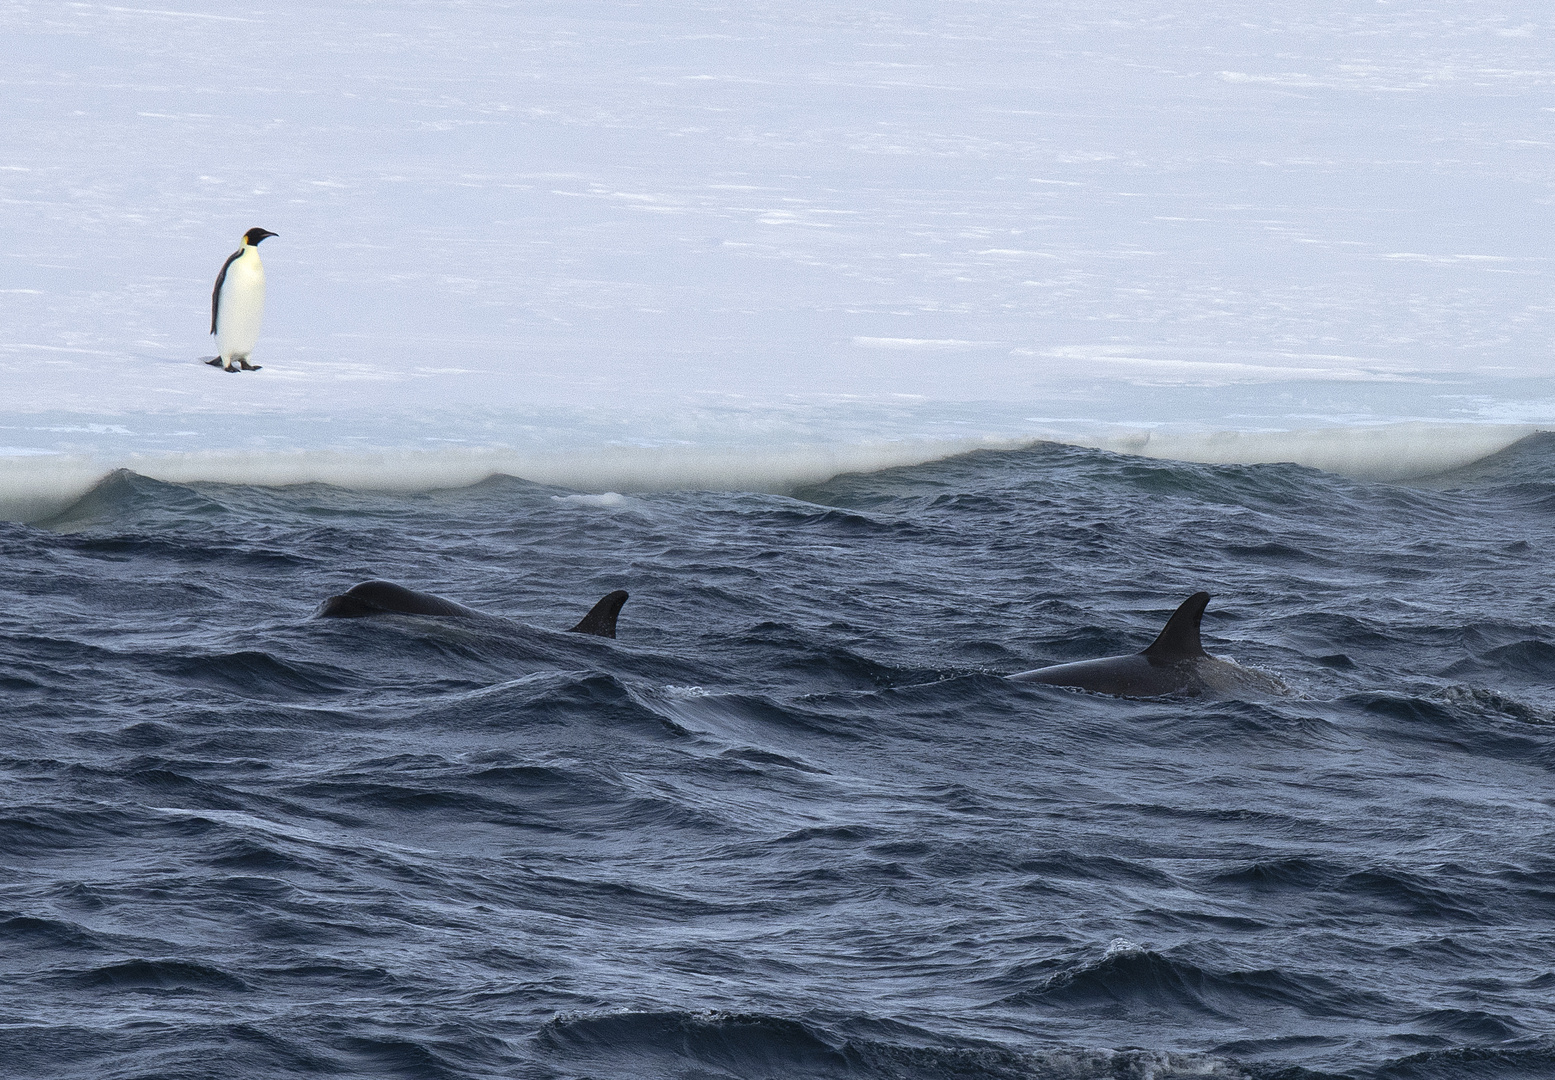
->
[[0, 0, 1555, 516]]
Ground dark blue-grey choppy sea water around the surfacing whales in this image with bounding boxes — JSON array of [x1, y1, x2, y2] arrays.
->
[[0, 437, 1555, 1080]]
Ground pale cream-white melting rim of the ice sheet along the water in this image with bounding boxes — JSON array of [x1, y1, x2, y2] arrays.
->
[[0, 423, 1538, 522]]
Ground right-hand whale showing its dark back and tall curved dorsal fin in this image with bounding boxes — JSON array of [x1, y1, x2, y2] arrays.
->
[[1009, 592, 1288, 698]]
